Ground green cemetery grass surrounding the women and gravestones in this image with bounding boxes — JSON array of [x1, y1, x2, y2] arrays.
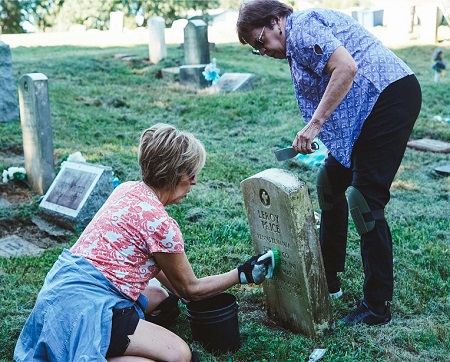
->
[[0, 44, 450, 361]]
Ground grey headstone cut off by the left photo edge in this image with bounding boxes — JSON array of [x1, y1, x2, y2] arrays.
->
[[0, 41, 19, 122]]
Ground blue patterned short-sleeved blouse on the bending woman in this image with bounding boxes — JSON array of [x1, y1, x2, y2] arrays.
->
[[286, 9, 413, 168]]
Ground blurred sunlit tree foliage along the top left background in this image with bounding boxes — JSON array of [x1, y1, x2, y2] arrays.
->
[[0, 0, 225, 33]]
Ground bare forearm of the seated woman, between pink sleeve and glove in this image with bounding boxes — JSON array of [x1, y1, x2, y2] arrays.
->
[[153, 253, 239, 300]]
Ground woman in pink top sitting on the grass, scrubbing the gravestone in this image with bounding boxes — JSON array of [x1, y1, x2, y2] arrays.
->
[[14, 124, 266, 362]]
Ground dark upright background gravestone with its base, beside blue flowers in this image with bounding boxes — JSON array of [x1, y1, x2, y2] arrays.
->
[[180, 19, 210, 88]]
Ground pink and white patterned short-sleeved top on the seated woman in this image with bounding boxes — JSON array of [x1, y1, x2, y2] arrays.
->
[[70, 181, 184, 300]]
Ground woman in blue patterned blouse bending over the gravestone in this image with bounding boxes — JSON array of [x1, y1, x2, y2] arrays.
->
[[237, 0, 422, 325]]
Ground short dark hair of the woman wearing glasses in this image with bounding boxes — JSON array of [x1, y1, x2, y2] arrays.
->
[[236, 0, 294, 44]]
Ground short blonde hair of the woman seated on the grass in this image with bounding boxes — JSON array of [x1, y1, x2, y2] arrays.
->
[[138, 123, 206, 190]]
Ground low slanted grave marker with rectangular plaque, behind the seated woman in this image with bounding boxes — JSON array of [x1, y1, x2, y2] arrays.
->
[[39, 161, 113, 231]]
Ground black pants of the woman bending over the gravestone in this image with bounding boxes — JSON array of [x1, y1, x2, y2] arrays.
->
[[320, 75, 422, 301]]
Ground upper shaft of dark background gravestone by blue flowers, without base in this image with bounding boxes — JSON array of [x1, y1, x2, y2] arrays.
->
[[184, 19, 210, 67]]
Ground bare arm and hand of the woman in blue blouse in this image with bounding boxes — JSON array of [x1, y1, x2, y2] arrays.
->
[[292, 46, 358, 154]]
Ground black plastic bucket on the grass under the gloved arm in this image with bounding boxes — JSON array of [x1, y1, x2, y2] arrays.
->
[[186, 293, 241, 354]]
